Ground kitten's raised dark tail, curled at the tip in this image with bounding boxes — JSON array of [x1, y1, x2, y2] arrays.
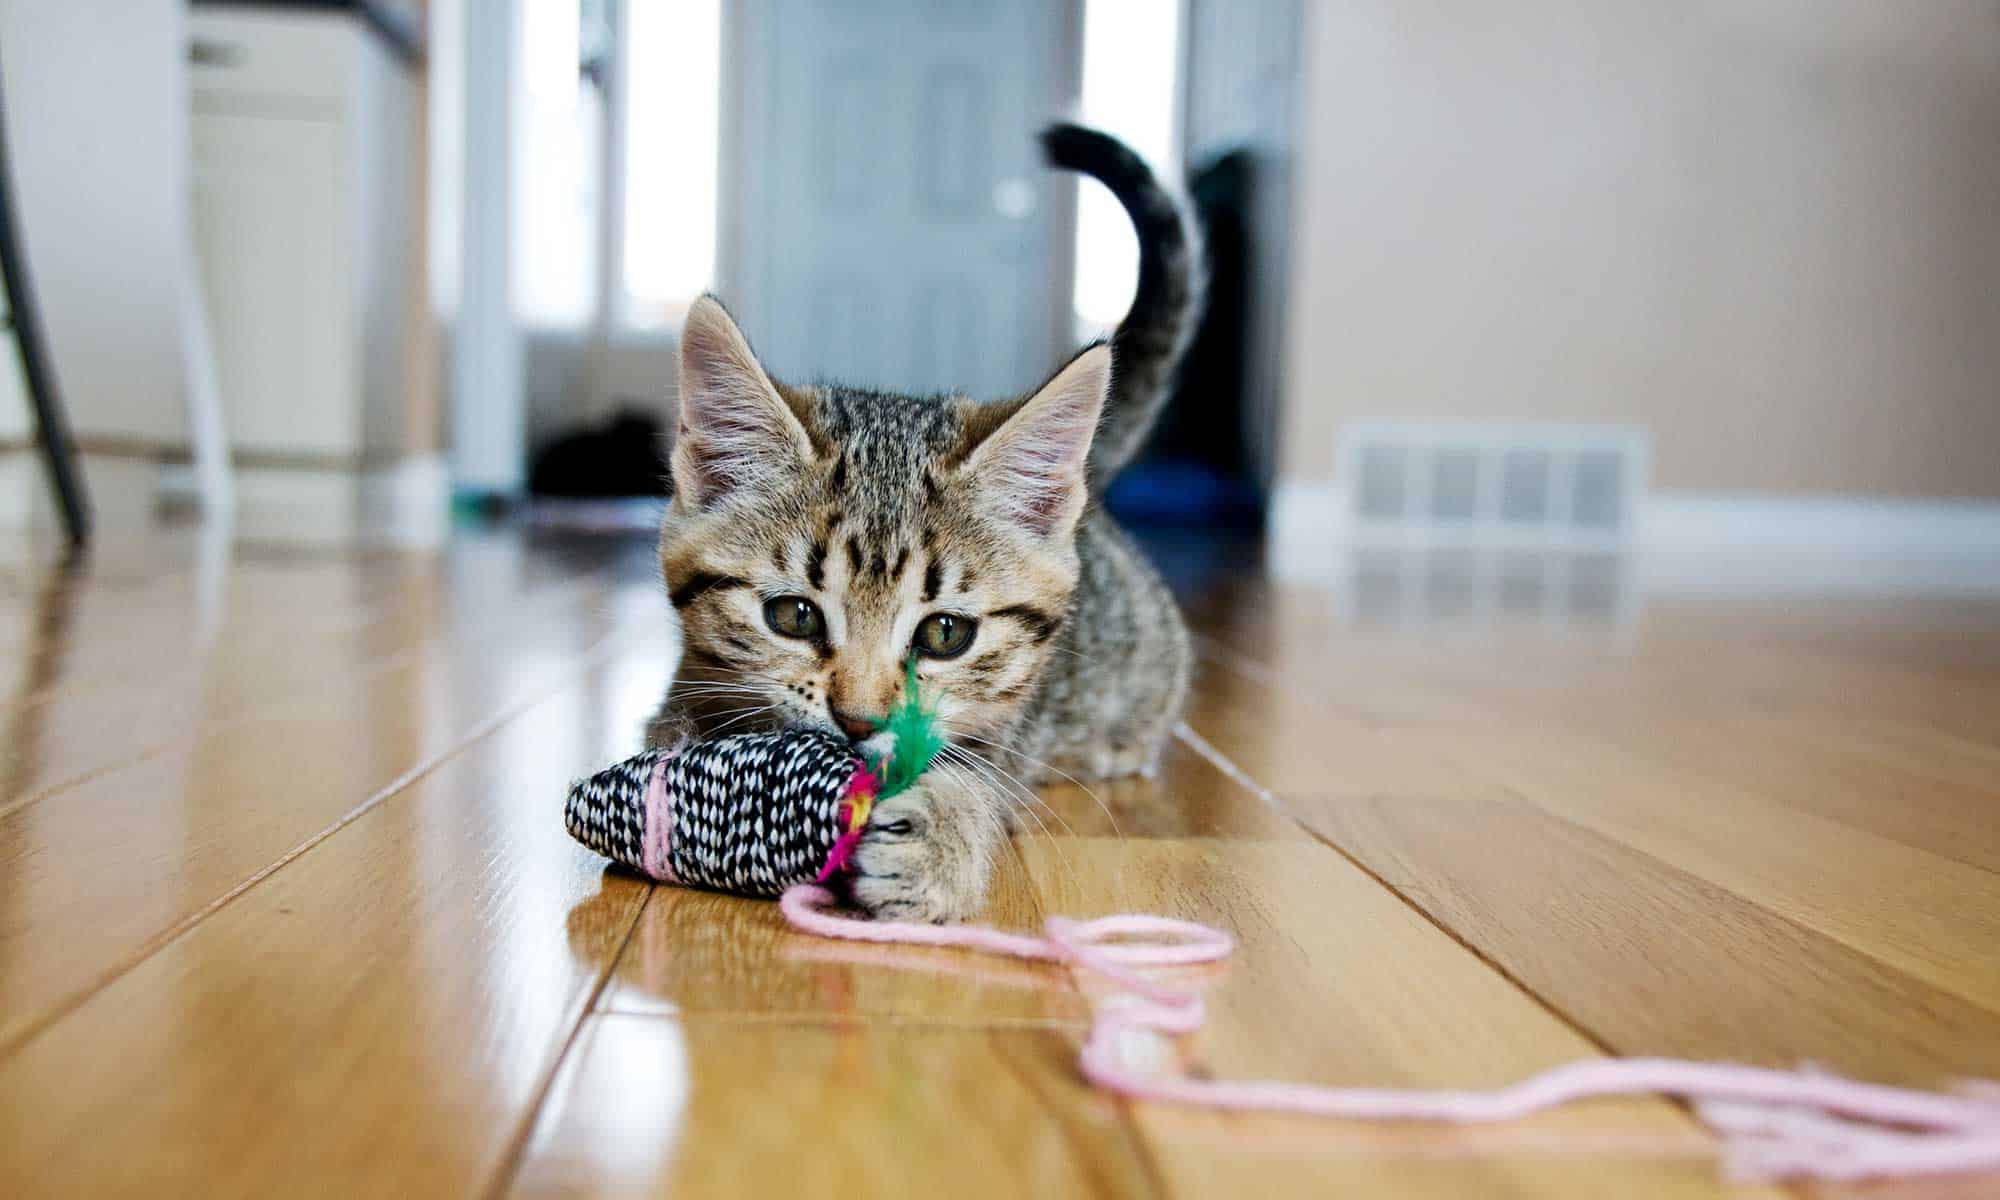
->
[[1042, 124, 1204, 492]]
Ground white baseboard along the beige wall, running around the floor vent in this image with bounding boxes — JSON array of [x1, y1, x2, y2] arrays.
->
[[1268, 482, 2000, 592]]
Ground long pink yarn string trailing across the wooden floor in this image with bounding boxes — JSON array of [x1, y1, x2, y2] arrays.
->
[[778, 884, 2000, 1180]]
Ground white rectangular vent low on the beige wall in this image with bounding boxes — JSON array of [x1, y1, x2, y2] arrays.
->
[[1338, 422, 1648, 548]]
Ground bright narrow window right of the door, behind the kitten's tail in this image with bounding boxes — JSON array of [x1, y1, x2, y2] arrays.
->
[[1074, 0, 1180, 334]]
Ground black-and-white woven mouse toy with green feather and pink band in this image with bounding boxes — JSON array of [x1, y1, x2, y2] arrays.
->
[[564, 680, 940, 896]]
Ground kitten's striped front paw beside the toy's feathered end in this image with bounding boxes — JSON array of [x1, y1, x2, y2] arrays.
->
[[852, 784, 988, 922]]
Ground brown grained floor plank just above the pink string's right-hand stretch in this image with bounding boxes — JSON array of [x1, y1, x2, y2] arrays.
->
[[1288, 796, 2000, 1086]]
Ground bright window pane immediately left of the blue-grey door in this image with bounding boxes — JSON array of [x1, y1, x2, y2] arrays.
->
[[624, 0, 722, 328]]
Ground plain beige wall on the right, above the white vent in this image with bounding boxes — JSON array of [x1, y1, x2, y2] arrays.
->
[[1282, 0, 2000, 498]]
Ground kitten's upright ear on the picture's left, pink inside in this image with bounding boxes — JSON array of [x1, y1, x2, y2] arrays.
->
[[672, 296, 812, 510]]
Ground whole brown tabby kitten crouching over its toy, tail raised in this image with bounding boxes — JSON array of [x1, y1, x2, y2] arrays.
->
[[650, 126, 1200, 920]]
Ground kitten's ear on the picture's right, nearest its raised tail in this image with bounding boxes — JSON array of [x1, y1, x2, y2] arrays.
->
[[966, 342, 1112, 538]]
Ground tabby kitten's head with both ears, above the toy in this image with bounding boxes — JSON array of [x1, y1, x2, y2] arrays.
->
[[660, 300, 1108, 740]]
